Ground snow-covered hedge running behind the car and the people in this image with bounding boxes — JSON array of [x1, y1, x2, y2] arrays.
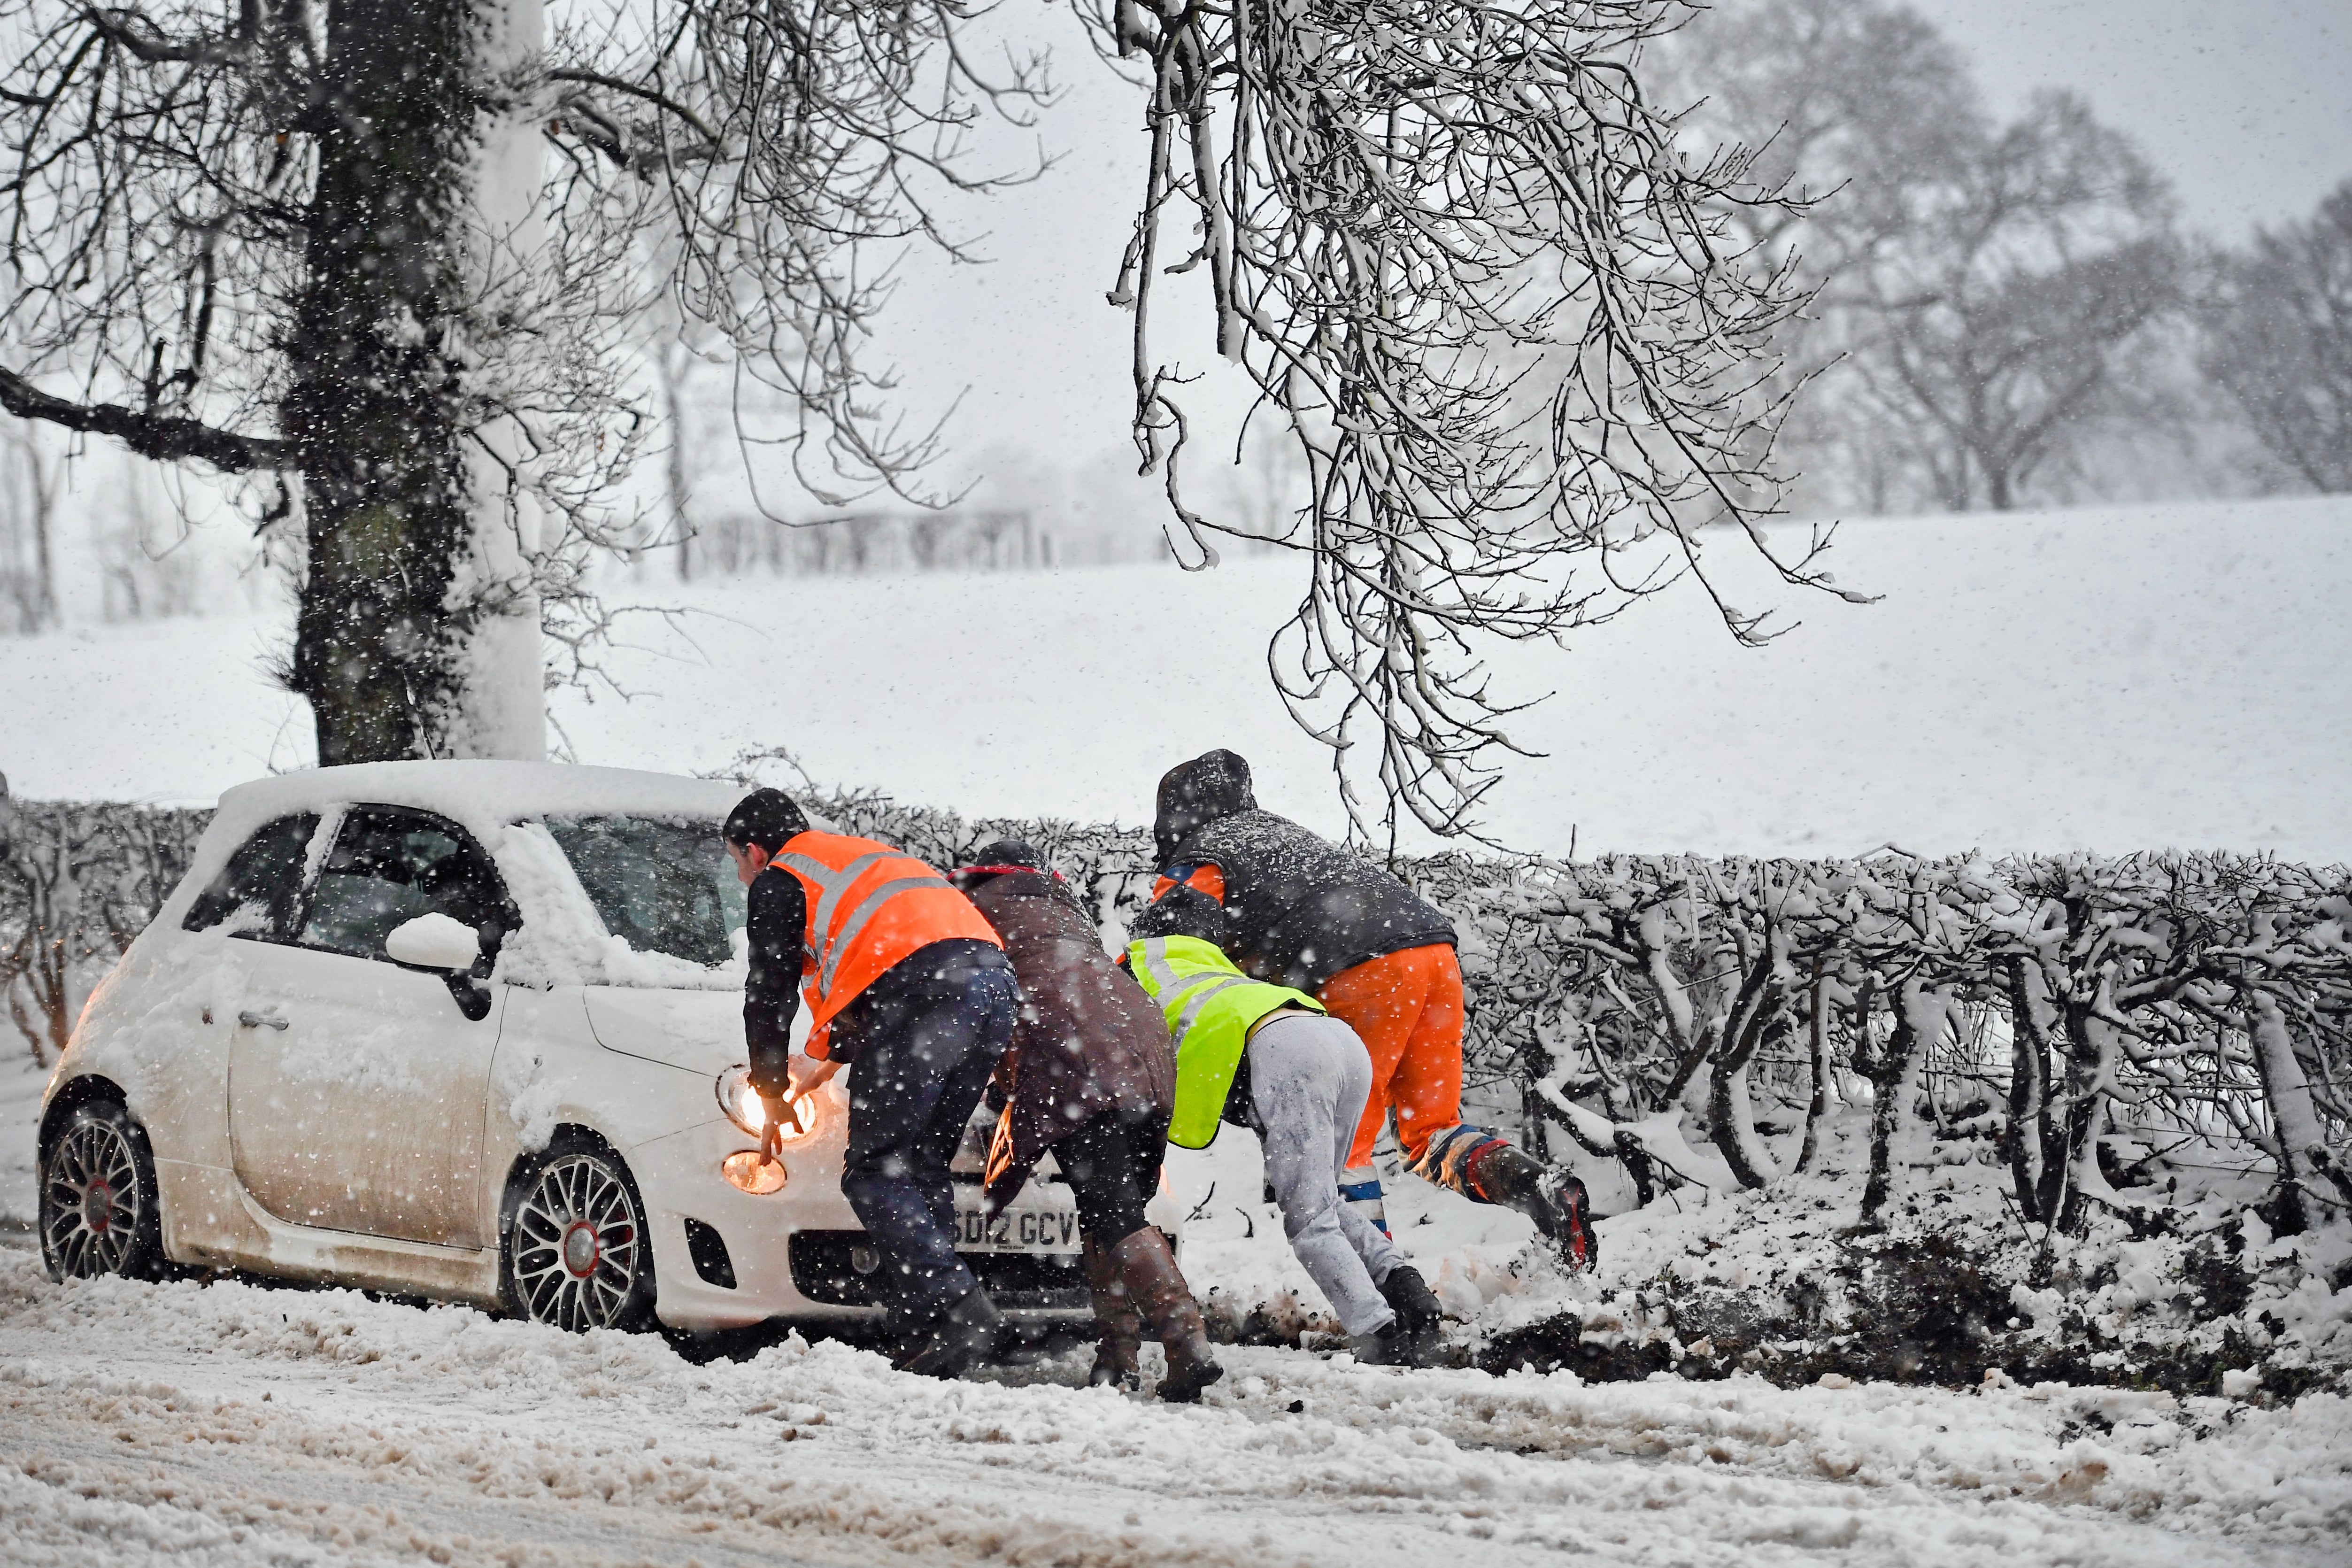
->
[[0, 795, 2352, 1232]]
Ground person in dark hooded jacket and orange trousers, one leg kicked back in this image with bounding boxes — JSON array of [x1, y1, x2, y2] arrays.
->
[[1152, 750, 1592, 1279]]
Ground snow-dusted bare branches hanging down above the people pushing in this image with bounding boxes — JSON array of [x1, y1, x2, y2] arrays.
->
[[1096, 0, 1842, 844]]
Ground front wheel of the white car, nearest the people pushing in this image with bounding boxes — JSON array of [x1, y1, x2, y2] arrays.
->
[[501, 1140, 654, 1333]]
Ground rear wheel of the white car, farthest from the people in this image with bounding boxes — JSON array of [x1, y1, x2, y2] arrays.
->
[[40, 1100, 165, 1279]]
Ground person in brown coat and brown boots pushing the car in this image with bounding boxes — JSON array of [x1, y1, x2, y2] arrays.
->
[[953, 839, 1226, 1404]]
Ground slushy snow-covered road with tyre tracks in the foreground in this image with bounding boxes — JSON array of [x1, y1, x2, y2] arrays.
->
[[0, 1248, 2352, 1568]]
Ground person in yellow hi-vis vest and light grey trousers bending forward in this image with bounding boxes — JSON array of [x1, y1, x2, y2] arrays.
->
[[1124, 926, 1440, 1366]]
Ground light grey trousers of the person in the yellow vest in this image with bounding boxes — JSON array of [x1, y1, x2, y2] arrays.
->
[[1249, 1013, 1404, 1335]]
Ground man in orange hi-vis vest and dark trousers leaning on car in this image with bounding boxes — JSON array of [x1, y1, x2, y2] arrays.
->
[[722, 790, 1021, 1378]]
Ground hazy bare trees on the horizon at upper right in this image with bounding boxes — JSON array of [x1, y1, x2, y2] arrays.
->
[[1660, 0, 2352, 512]]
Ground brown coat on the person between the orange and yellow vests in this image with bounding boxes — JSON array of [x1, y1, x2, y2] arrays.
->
[[972, 872, 1176, 1208]]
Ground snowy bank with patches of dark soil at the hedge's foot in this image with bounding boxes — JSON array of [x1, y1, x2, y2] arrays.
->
[[1463, 1110, 2352, 1420]]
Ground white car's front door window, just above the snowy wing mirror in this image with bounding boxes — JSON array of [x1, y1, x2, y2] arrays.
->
[[299, 806, 515, 961]]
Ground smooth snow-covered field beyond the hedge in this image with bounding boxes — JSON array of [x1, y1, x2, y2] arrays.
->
[[0, 496, 2352, 860]]
